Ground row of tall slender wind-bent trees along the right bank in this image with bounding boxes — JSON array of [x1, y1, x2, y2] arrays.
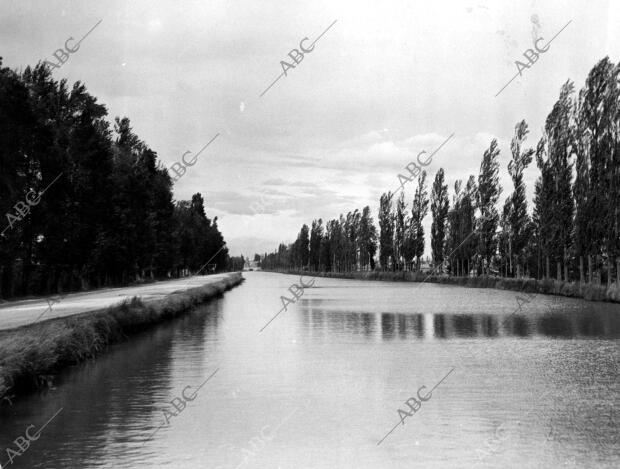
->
[[261, 58, 620, 284]]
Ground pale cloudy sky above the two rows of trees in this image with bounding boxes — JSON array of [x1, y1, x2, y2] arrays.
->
[[0, 0, 620, 257]]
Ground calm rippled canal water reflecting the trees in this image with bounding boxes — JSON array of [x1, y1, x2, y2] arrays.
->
[[0, 272, 620, 469]]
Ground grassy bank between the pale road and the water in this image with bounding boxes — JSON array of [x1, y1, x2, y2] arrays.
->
[[0, 272, 245, 405]]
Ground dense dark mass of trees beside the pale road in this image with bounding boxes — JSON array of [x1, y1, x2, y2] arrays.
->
[[0, 58, 229, 297]]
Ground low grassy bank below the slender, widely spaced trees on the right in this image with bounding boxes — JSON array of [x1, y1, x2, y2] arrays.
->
[[264, 269, 620, 303]]
